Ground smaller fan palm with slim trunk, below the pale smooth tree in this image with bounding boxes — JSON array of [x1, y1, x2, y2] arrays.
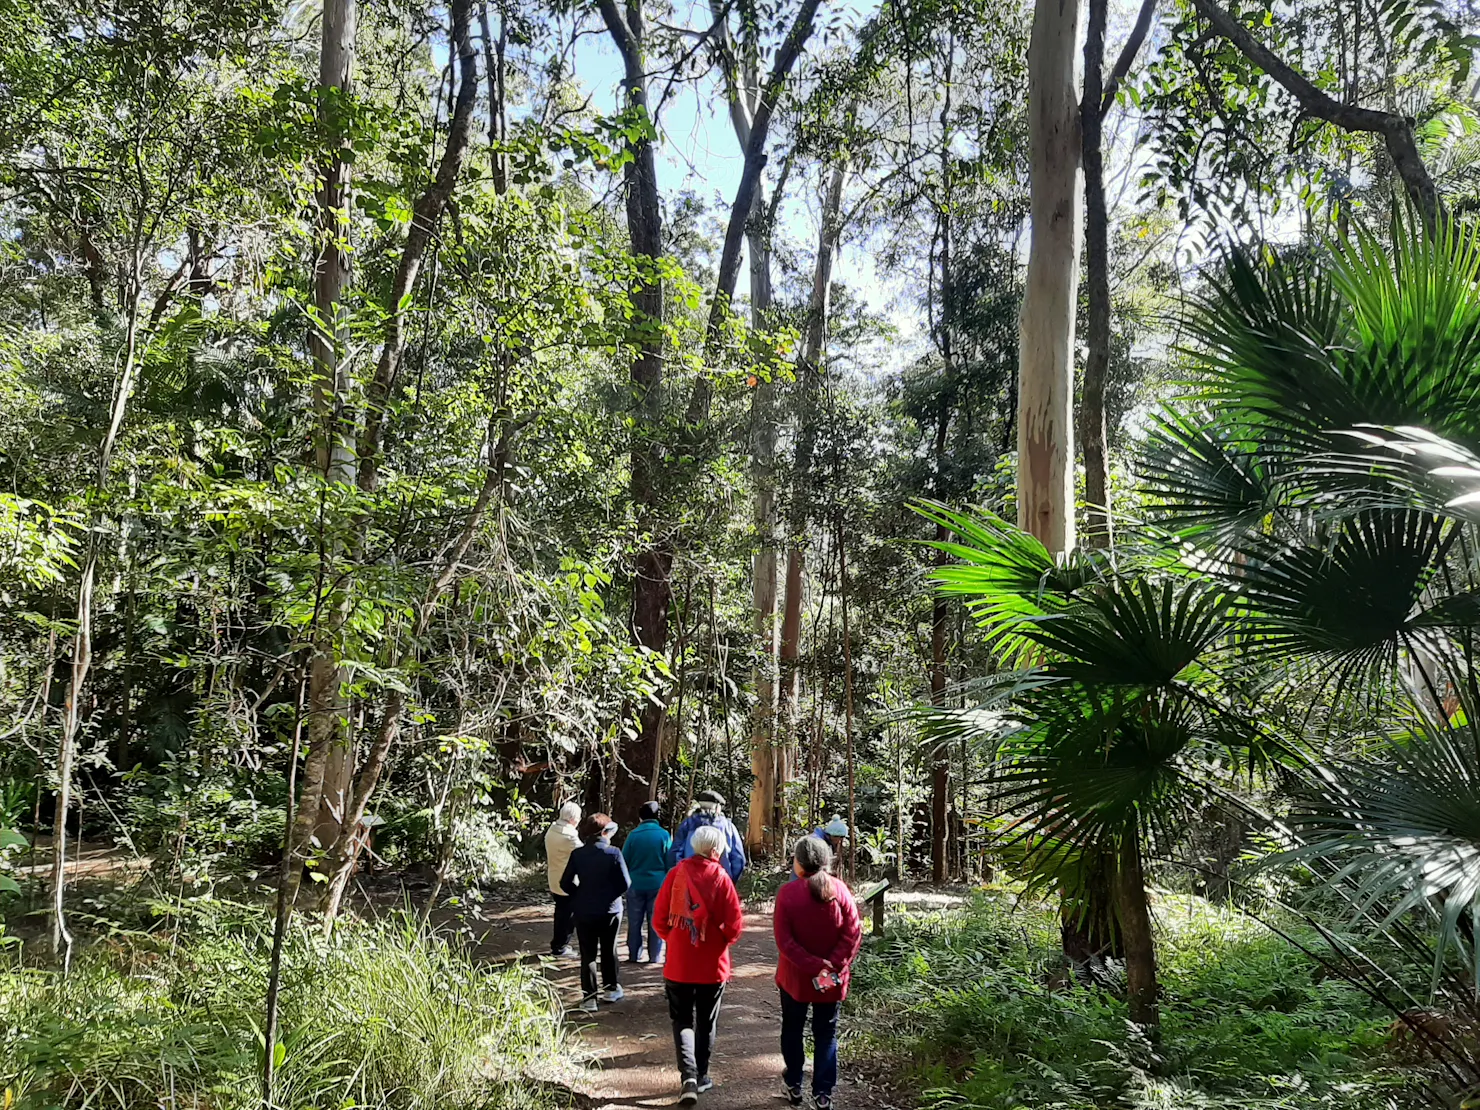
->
[[919, 505, 1265, 1026]]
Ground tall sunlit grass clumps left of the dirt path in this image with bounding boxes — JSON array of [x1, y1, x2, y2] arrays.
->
[[0, 909, 561, 1110]]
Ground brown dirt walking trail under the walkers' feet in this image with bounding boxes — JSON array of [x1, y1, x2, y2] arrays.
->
[[477, 906, 906, 1110]]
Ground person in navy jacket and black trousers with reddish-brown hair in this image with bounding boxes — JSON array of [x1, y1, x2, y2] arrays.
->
[[559, 813, 632, 1012]]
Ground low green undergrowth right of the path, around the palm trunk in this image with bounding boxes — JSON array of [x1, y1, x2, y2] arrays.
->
[[851, 894, 1424, 1110]]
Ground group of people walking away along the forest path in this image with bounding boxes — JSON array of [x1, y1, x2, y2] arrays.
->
[[545, 790, 863, 1110]]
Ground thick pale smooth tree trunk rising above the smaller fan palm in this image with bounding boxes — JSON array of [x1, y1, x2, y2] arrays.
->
[[1018, 0, 1080, 551]]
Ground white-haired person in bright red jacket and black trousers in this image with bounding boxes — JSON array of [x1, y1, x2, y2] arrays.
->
[[653, 824, 744, 1106]]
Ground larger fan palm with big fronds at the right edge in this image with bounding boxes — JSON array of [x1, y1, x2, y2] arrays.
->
[[1143, 221, 1480, 1036]]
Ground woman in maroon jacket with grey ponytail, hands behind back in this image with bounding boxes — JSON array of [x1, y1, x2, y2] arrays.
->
[[776, 836, 863, 1110]]
